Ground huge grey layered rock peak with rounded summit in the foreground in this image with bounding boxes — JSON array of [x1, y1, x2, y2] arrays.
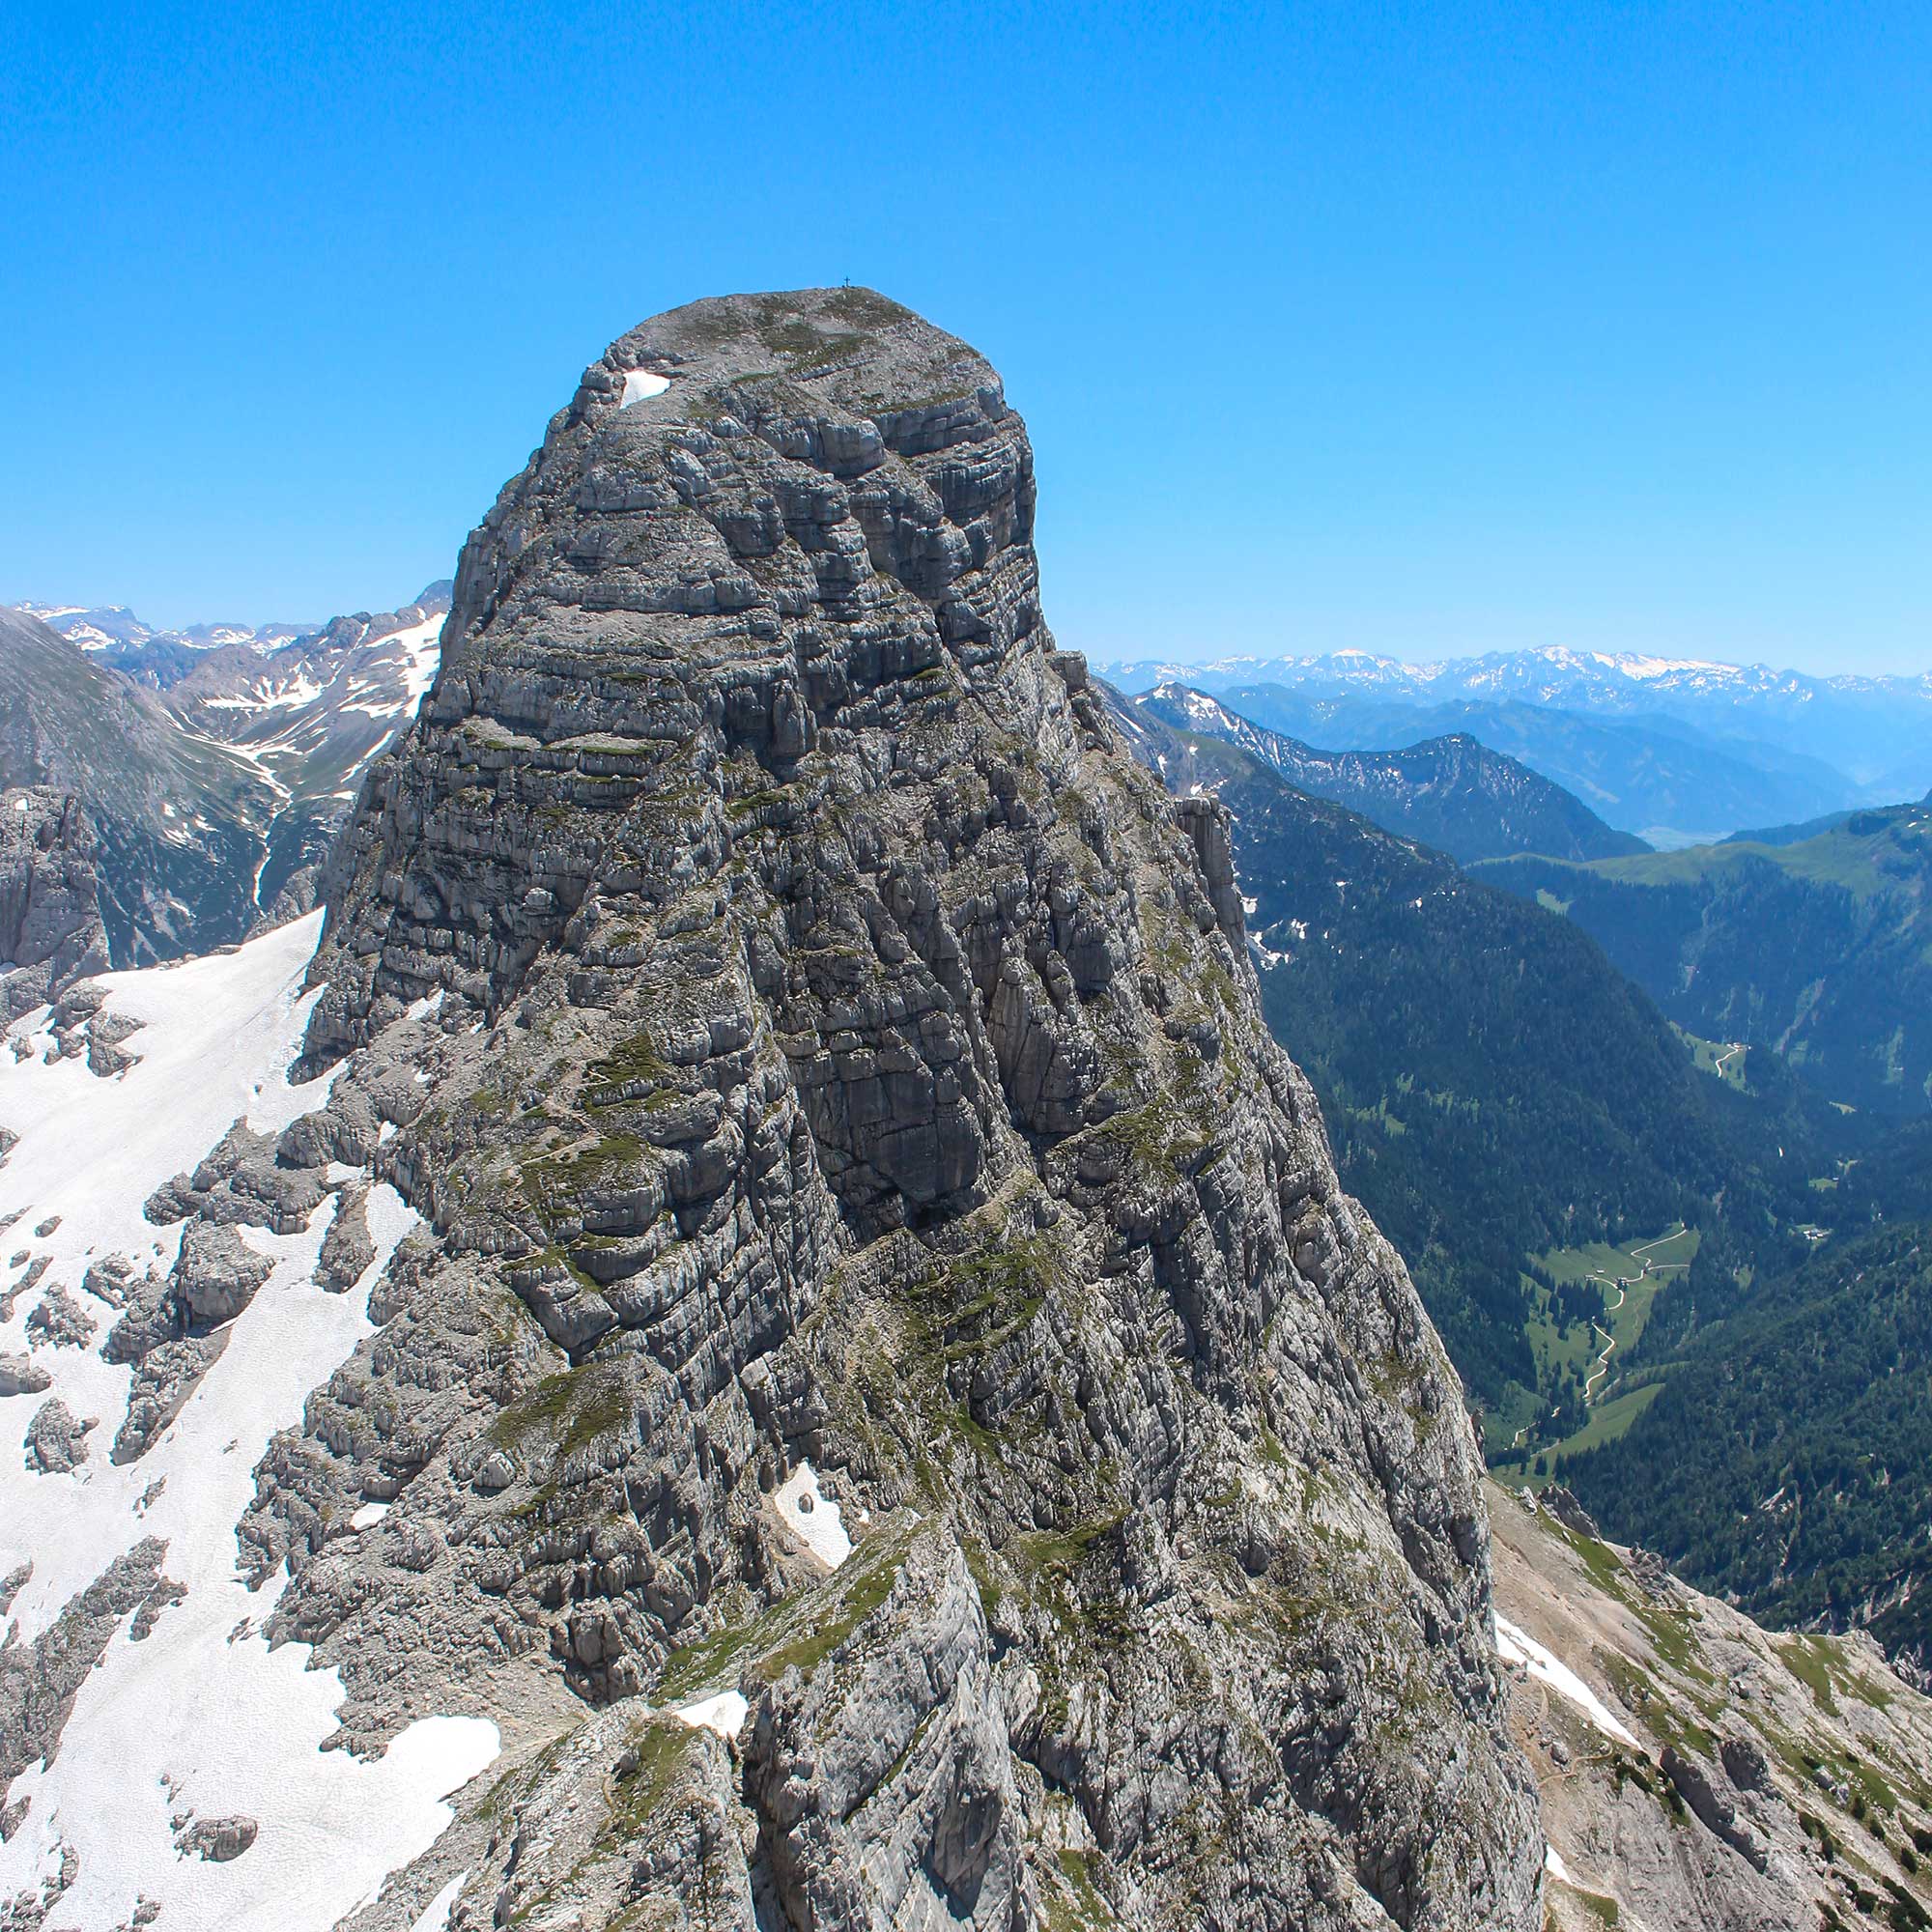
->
[[276, 288, 1544, 1932]]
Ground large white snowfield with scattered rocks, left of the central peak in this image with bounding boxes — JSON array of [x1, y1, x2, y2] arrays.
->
[[0, 914, 498, 1932]]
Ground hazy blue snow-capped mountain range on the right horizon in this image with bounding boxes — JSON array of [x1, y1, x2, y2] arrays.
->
[[1095, 645, 1932, 844]]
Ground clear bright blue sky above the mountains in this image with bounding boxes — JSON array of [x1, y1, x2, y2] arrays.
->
[[0, 0, 1932, 668]]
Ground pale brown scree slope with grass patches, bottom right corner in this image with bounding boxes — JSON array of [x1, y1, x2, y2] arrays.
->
[[1492, 1488, 1932, 1932]]
